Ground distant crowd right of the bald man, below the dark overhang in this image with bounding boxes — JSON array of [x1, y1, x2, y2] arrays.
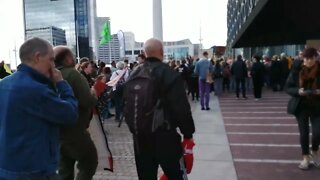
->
[[152, 52, 303, 104]]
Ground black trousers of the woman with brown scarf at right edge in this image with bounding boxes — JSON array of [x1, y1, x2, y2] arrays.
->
[[296, 112, 320, 155]]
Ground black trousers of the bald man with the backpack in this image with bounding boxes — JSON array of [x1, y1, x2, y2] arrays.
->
[[133, 132, 187, 180]]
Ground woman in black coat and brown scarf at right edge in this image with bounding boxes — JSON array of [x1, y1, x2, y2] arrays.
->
[[286, 48, 320, 170]]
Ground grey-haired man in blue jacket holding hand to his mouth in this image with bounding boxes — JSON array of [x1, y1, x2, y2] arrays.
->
[[0, 38, 78, 180]]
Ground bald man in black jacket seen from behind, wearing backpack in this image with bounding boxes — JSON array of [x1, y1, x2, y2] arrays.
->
[[125, 39, 195, 180]]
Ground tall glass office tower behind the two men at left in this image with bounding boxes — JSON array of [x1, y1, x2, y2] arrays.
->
[[23, 0, 92, 57]]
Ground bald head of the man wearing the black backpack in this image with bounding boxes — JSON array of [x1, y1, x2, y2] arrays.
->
[[144, 38, 163, 61]]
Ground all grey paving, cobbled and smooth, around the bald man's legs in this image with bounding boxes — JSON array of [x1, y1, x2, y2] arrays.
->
[[94, 96, 237, 180]]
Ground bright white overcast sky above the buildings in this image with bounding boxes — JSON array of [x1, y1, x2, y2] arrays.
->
[[0, 0, 227, 64]]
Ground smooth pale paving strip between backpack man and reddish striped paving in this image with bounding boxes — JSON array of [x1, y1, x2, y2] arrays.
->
[[189, 96, 237, 180]]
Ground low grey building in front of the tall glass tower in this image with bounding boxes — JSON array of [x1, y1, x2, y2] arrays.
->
[[26, 26, 67, 46]]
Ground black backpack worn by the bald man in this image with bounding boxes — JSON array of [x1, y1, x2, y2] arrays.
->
[[124, 63, 170, 135]]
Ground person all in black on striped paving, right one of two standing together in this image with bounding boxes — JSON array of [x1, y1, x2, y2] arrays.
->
[[251, 56, 265, 100]]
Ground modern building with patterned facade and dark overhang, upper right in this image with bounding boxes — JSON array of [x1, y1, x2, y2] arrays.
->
[[227, 0, 320, 58]]
